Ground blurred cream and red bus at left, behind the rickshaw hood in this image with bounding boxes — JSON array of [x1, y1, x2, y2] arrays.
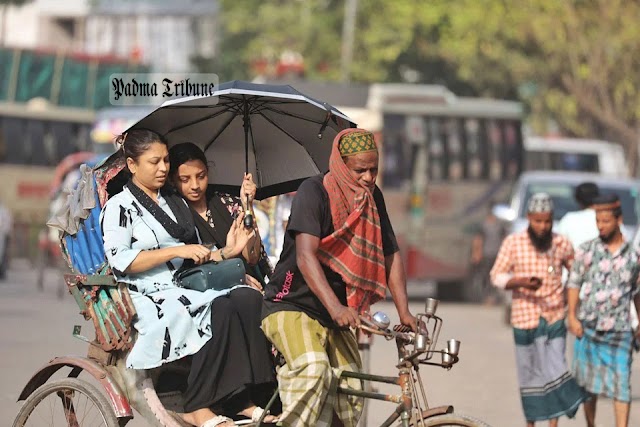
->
[[0, 99, 151, 256]]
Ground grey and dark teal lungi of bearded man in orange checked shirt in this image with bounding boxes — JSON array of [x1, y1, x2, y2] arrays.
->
[[513, 318, 588, 421]]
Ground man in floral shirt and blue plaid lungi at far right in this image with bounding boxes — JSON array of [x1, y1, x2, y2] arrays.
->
[[568, 195, 640, 427]]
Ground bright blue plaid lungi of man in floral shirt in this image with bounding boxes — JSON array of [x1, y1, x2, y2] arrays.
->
[[573, 328, 634, 402]]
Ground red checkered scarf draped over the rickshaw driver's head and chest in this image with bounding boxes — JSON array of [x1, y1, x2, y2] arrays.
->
[[318, 129, 387, 313]]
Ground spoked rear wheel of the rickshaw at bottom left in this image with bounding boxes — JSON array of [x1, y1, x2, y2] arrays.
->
[[13, 378, 122, 427]]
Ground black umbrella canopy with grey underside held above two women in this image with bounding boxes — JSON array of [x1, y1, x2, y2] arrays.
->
[[129, 81, 355, 200]]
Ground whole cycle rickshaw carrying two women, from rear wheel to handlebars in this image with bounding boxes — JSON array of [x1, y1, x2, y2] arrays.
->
[[13, 150, 486, 427]]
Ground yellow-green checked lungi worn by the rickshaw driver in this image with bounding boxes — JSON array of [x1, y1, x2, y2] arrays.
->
[[262, 311, 363, 427]]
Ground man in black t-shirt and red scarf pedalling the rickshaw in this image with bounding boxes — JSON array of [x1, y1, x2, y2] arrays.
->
[[262, 129, 416, 426]]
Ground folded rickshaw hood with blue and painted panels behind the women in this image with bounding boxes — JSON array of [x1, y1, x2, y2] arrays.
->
[[52, 150, 136, 356]]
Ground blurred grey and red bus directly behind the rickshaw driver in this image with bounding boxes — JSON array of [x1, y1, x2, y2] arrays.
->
[[337, 84, 524, 296]]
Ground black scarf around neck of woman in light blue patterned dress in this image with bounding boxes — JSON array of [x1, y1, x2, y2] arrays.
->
[[126, 179, 198, 244]]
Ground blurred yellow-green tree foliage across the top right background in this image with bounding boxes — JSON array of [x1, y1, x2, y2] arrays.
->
[[221, 0, 640, 174]]
